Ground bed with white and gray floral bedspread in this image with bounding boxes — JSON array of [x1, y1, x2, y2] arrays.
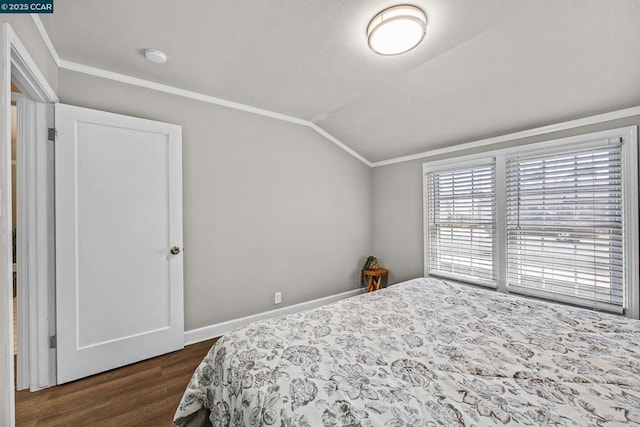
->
[[174, 278, 640, 427]]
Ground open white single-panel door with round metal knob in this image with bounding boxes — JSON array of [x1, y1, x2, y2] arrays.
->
[[55, 104, 184, 384]]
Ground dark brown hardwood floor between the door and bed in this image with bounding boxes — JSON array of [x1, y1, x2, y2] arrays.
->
[[16, 340, 216, 427]]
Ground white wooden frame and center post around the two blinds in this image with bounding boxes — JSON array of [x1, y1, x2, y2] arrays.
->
[[422, 126, 640, 319]]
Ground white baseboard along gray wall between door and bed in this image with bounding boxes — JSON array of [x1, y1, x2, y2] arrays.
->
[[184, 288, 364, 345]]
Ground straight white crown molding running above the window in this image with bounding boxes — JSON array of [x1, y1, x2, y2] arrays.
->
[[371, 106, 640, 168]]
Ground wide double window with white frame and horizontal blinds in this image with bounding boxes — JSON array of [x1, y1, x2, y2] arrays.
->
[[423, 127, 640, 318]]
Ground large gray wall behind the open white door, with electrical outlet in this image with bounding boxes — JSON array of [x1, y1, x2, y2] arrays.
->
[[58, 70, 372, 330]]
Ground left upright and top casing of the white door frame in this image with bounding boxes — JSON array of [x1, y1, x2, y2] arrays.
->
[[0, 23, 58, 425]]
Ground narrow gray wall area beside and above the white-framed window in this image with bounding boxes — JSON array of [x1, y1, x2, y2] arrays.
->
[[372, 116, 640, 283]]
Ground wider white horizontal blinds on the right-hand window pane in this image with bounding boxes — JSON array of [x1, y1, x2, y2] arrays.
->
[[507, 140, 624, 312]]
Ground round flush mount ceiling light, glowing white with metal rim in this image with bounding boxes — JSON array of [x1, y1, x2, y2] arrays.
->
[[367, 5, 427, 55]]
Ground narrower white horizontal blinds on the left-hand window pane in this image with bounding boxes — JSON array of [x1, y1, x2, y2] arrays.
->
[[426, 159, 496, 287]]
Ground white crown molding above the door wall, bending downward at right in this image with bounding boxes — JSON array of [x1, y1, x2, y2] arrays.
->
[[31, 14, 371, 167]]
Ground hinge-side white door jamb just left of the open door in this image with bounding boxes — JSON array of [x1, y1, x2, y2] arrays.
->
[[11, 93, 56, 391]]
